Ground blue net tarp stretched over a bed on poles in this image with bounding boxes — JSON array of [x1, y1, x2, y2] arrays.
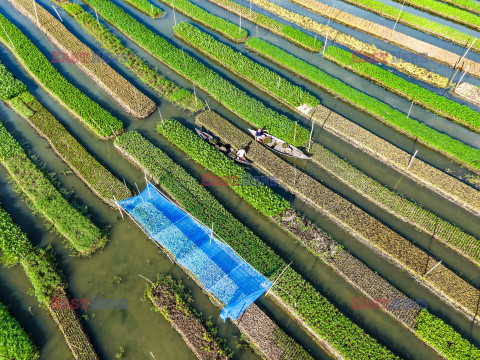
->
[[119, 183, 272, 320]]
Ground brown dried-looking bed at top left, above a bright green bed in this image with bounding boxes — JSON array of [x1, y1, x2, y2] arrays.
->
[[9, 0, 157, 118]]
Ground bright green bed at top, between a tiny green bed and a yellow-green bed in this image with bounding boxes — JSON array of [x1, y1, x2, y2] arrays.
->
[[160, 0, 248, 43]]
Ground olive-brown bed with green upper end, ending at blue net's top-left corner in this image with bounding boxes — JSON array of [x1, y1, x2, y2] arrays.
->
[[0, 59, 131, 206]]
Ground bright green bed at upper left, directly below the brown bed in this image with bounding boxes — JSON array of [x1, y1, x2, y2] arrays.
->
[[0, 14, 123, 139]]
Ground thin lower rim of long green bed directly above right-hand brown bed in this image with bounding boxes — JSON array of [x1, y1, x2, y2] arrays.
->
[[245, 44, 480, 175]]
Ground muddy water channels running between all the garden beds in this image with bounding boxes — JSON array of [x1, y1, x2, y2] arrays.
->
[[0, 0, 480, 359]]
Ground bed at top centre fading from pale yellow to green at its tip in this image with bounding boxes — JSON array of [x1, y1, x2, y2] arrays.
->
[[206, 0, 323, 52]]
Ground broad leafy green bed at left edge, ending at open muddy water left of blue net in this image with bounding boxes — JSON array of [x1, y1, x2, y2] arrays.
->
[[0, 124, 107, 256]]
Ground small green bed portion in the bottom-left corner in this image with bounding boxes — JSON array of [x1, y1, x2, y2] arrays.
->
[[0, 300, 39, 360]]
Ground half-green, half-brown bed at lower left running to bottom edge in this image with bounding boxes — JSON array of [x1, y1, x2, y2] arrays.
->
[[0, 207, 98, 360]]
